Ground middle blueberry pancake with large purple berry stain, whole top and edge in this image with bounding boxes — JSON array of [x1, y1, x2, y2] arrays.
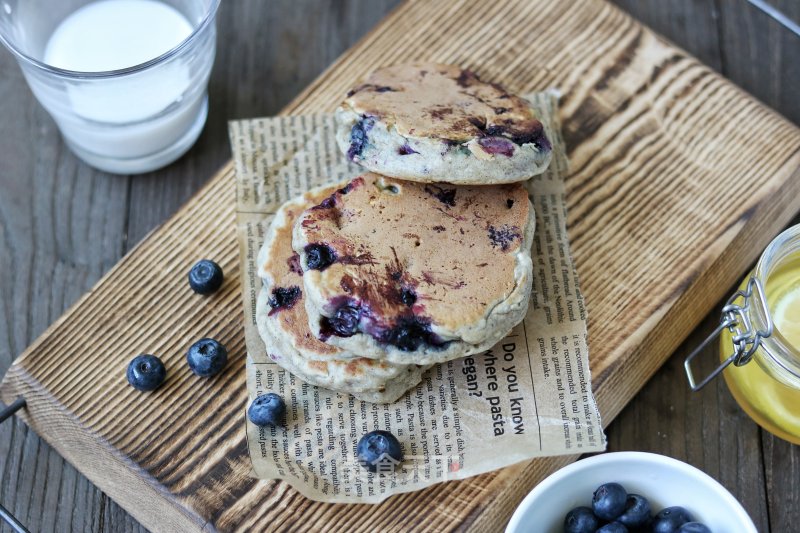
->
[[292, 173, 535, 365]]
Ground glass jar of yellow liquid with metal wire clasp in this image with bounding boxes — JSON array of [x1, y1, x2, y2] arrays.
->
[[684, 225, 800, 444]]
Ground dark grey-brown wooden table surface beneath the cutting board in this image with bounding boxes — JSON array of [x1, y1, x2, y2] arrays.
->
[[0, 0, 800, 532]]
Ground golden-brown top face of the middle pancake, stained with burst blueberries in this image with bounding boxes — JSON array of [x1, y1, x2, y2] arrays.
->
[[295, 173, 532, 336]]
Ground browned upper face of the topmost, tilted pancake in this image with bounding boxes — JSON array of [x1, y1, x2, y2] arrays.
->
[[344, 63, 543, 144]]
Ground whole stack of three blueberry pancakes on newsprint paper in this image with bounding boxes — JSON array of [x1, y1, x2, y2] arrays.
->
[[256, 64, 550, 403]]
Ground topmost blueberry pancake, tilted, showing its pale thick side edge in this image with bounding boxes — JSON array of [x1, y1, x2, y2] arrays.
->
[[336, 63, 550, 185]]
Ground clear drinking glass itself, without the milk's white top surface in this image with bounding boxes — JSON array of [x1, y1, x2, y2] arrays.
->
[[0, 0, 220, 174]]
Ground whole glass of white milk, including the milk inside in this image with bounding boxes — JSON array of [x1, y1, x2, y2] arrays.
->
[[0, 0, 220, 174]]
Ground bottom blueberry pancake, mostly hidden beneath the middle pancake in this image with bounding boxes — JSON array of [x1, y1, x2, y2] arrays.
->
[[256, 187, 426, 402]]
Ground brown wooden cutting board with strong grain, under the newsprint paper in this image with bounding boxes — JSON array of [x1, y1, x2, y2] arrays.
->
[[0, 0, 800, 531]]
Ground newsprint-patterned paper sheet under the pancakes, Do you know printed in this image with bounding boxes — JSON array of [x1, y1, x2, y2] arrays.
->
[[229, 93, 605, 503]]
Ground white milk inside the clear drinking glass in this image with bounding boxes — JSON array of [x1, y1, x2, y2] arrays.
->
[[32, 0, 213, 173]]
